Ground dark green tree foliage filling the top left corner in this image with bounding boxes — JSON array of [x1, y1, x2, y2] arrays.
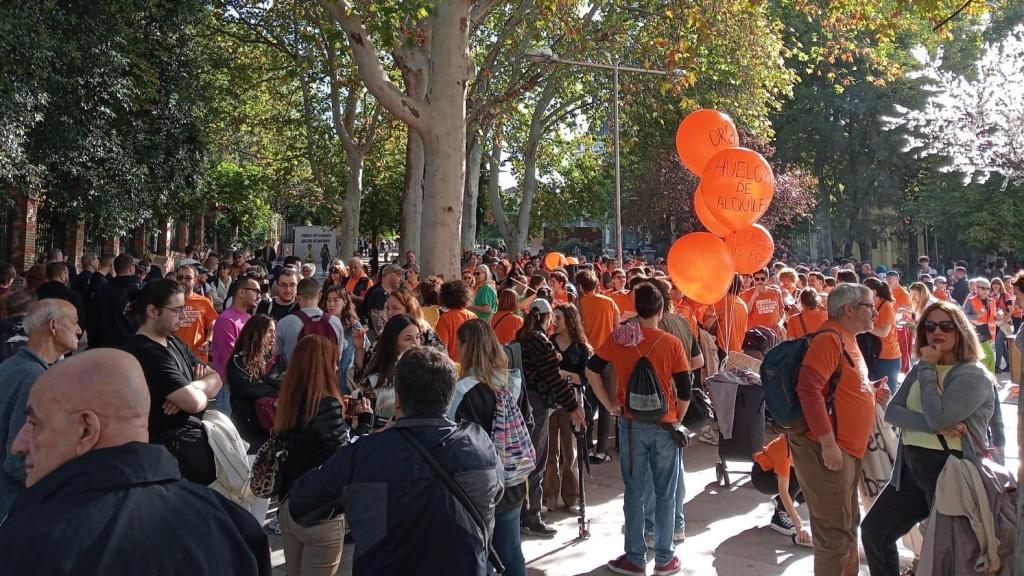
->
[[0, 0, 207, 234]]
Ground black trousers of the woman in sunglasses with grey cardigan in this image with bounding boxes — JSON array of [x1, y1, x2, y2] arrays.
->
[[860, 446, 963, 576]]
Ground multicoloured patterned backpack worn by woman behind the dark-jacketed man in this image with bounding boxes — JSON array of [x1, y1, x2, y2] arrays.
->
[[449, 370, 537, 486]]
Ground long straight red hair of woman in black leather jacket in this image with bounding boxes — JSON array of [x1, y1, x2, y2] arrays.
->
[[273, 334, 341, 433]]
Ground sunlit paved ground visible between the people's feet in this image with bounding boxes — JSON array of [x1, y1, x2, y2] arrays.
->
[[271, 375, 1018, 576]]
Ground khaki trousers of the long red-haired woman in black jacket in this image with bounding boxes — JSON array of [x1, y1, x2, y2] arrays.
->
[[278, 500, 345, 576]]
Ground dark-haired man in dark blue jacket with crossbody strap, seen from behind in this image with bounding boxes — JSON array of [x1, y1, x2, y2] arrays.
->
[[289, 346, 501, 576]]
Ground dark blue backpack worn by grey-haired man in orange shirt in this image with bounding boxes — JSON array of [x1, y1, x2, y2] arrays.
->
[[761, 329, 850, 428]]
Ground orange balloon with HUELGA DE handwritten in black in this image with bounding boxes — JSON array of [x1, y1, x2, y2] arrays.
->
[[700, 148, 775, 232]]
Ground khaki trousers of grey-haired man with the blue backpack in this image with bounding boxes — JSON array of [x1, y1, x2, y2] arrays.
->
[[788, 434, 860, 576]]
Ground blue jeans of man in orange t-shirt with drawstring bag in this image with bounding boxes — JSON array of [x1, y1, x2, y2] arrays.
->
[[618, 418, 679, 566]]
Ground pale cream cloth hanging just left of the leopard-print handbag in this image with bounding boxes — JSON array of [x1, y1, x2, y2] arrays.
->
[[203, 410, 253, 507]]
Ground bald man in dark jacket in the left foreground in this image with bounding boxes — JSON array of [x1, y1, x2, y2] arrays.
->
[[0, 348, 270, 576]]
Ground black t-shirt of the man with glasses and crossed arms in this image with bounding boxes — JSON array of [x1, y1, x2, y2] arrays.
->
[[124, 334, 202, 434]]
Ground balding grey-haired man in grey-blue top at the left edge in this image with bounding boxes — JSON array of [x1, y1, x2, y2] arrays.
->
[[0, 298, 82, 518]]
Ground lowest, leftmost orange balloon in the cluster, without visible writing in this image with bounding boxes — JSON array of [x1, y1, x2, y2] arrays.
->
[[668, 232, 735, 304]]
